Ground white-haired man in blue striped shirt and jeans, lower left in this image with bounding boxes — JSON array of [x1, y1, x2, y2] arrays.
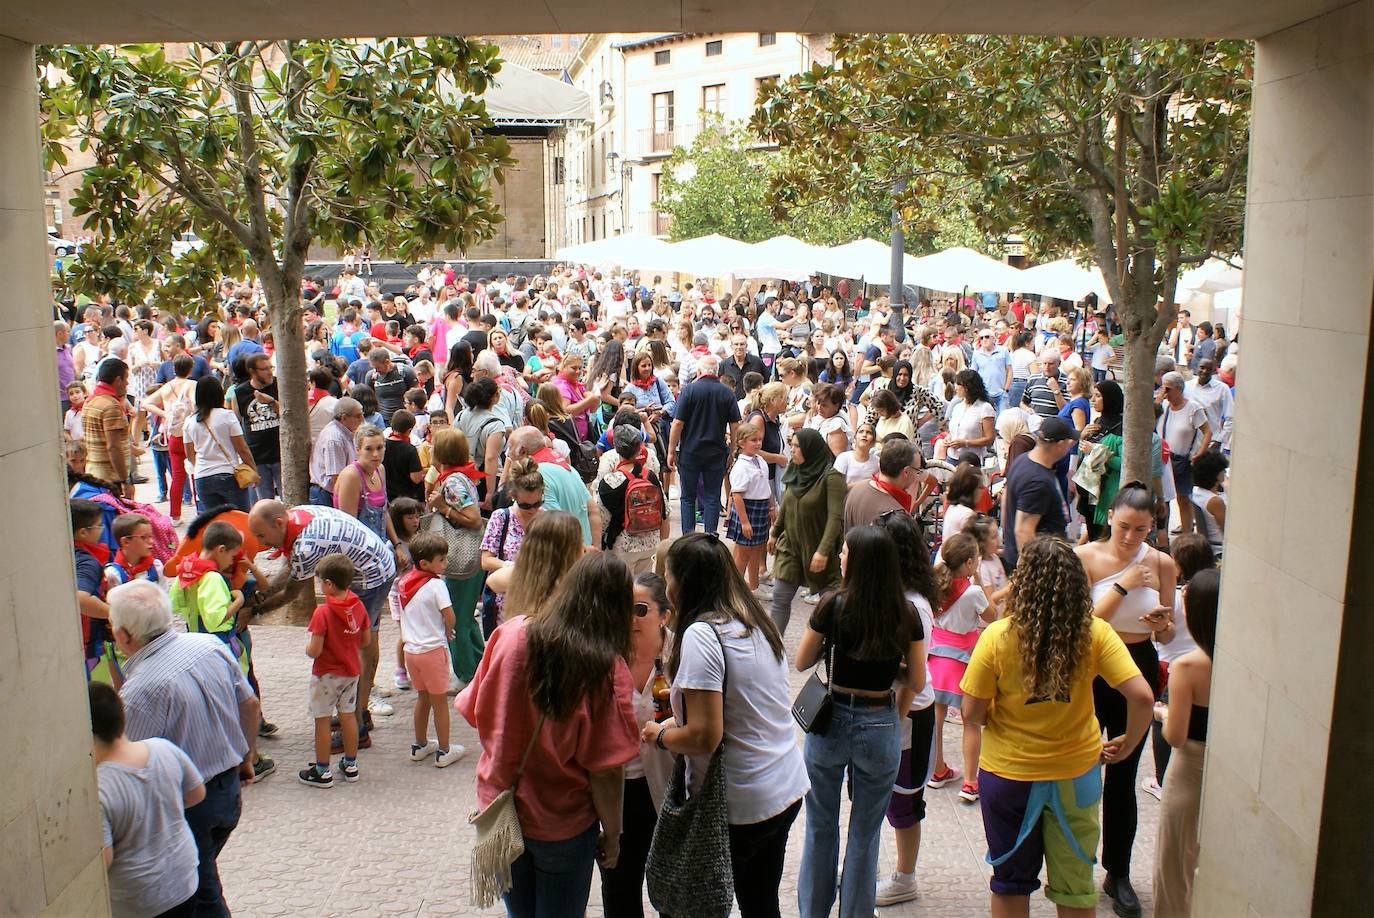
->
[[107, 580, 261, 915]]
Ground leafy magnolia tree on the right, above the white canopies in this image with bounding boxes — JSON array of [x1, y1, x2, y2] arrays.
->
[[753, 36, 1250, 481]]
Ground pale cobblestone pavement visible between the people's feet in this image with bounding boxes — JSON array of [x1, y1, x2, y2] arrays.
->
[[220, 602, 1158, 918]]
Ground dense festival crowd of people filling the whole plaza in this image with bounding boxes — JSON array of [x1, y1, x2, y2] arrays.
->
[[55, 265, 1239, 918]]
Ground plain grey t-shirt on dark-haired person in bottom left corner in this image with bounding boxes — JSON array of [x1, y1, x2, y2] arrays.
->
[[96, 738, 201, 918]]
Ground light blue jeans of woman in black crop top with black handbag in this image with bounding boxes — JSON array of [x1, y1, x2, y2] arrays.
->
[[797, 701, 901, 918]]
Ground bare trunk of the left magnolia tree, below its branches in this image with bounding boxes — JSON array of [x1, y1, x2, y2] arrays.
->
[[262, 279, 311, 506]]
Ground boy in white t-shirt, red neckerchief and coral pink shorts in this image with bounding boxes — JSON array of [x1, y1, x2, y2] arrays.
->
[[397, 532, 467, 768]]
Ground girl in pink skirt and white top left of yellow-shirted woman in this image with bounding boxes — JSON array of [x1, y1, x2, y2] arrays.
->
[[929, 532, 996, 803]]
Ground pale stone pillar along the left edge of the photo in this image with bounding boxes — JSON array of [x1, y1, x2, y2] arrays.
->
[[0, 37, 110, 917]]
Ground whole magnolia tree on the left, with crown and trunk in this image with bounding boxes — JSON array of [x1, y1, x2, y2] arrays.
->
[[38, 37, 514, 503]]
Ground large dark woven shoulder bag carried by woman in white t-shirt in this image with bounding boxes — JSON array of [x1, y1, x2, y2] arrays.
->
[[644, 625, 735, 918]]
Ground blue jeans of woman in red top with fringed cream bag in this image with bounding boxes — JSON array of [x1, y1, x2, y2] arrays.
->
[[506, 823, 599, 918]]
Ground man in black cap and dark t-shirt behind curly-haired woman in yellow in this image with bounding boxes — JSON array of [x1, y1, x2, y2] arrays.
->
[[1002, 418, 1079, 568]]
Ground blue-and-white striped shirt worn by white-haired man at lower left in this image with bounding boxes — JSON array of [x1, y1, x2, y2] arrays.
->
[[120, 631, 253, 781]]
